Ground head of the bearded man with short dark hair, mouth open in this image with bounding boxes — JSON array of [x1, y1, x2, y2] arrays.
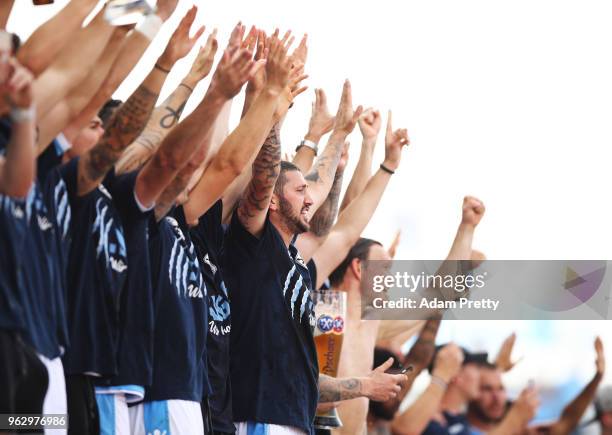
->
[[270, 171, 313, 242]]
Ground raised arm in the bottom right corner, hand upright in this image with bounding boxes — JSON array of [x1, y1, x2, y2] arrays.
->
[[549, 337, 606, 435]]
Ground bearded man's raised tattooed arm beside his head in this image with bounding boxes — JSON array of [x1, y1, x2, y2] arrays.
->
[[237, 125, 281, 232]]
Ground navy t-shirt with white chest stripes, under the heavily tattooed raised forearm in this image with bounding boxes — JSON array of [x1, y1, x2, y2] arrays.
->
[[61, 158, 134, 377]]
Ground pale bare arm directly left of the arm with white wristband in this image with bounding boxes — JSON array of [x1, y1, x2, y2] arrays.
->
[[29, 10, 114, 119]]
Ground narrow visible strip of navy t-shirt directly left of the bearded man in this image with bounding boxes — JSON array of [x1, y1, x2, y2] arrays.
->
[[189, 200, 235, 433]]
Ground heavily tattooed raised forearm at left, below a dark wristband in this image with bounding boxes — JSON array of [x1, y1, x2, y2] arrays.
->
[[78, 84, 158, 195]]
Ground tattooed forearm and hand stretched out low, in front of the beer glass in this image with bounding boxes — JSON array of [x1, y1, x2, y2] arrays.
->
[[319, 358, 406, 403]]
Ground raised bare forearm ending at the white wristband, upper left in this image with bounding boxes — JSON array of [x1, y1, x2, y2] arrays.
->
[[37, 27, 127, 154]]
